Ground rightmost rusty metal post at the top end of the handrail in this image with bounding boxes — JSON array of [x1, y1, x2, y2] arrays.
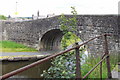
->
[[104, 35, 112, 79]]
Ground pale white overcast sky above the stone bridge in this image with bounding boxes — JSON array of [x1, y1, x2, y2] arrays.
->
[[0, 0, 119, 17]]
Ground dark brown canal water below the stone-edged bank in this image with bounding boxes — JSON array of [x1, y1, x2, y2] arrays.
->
[[0, 61, 51, 78]]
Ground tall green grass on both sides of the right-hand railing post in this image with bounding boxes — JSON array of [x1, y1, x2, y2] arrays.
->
[[82, 57, 119, 78]]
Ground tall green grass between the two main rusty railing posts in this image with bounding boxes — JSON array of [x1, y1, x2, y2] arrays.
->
[[81, 55, 107, 78]]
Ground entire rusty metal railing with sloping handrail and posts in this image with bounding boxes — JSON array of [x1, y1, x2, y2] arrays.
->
[[0, 34, 112, 80]]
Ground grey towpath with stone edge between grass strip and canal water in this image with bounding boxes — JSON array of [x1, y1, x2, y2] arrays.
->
[[0, 51, 56, 61]]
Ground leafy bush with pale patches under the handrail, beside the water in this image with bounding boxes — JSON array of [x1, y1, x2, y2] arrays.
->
[[41, 51, 86, 78]]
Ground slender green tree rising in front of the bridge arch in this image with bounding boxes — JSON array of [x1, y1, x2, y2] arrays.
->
[[59, 7, 78, 45]]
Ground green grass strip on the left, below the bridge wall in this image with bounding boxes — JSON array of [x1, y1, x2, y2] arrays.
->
[[0, 41, 37, 52]]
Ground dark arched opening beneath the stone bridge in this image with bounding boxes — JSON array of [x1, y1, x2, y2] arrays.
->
[[40, 29, 63, 50]]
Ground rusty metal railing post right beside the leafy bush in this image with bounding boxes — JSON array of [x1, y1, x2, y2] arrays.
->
[[75, 43, 82, 80]]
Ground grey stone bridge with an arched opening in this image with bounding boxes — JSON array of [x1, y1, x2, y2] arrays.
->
[[0, 15, 120, 53]]
